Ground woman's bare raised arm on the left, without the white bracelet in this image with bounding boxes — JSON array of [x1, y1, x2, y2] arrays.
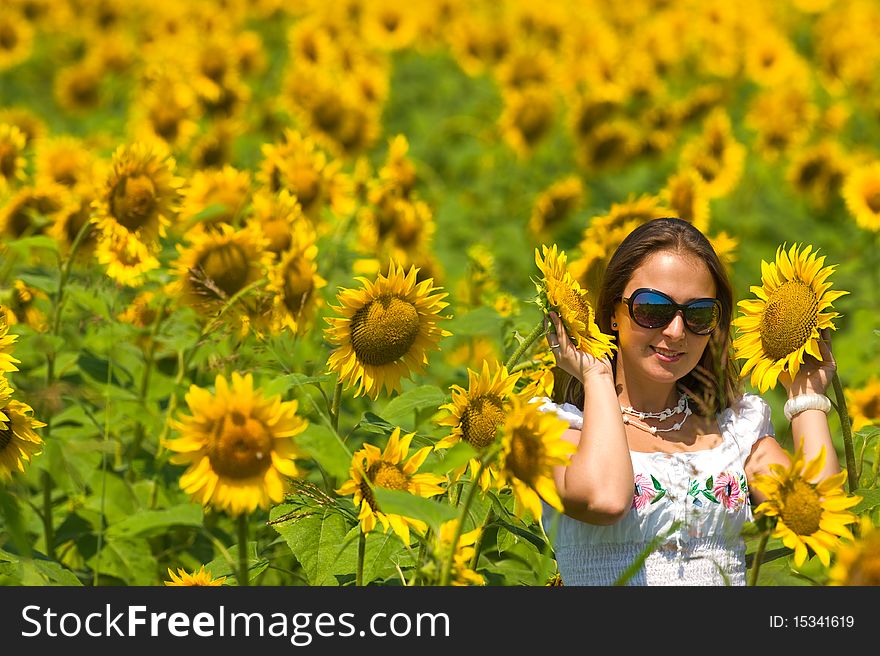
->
[[550, 312, 633, 524]]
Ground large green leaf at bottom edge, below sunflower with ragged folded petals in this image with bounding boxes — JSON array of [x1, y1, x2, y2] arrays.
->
[[272, 508, 349, 585]]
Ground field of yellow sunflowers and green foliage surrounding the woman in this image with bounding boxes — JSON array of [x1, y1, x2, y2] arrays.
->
[[0, 0, 880, 586]]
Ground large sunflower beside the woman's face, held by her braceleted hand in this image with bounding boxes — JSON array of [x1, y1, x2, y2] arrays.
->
[[733, 244, 849, 393]]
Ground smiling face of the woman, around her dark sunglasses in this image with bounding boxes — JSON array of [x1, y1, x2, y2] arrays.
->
[[613, 251, 716, 383]]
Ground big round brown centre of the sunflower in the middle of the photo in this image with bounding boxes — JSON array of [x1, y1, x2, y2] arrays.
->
[[351, 294, 419, 366]]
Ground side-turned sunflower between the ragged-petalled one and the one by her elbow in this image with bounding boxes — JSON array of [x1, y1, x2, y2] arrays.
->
[[434, 360, 520, 490]]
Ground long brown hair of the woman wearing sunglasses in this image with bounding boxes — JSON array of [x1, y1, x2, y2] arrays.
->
[[554, 218, 740, 416]]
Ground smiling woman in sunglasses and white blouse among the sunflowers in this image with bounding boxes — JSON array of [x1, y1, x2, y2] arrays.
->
[[542, 218, 840, 585]]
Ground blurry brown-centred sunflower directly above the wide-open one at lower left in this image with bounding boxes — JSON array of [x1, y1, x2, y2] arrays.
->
[[171, 223, 272, 314]]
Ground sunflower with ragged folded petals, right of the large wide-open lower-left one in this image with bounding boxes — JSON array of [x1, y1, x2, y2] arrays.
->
[[336, 427, 446, 545]]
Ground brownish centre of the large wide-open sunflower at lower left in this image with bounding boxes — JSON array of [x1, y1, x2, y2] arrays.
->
[[208, 410, 272, 479]]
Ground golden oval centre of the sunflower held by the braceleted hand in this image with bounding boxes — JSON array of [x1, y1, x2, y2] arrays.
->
[[760, 280, 819, 360]]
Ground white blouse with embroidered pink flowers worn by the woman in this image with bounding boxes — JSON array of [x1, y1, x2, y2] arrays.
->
[[534, 394, 774, 586]]
